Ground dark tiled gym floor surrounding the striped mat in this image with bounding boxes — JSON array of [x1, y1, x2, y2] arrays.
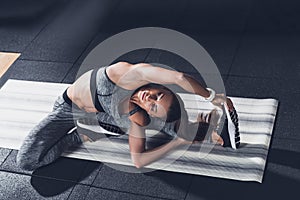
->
[[0, 0, 300, 200]]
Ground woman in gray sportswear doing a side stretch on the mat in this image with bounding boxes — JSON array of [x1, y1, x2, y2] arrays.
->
[[17, 62, 233, 170]]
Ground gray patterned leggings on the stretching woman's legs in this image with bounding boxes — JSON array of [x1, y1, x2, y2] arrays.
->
[[17, 96, 176, 170]]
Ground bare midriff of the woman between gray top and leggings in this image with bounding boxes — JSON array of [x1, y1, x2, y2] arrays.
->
[[67, 70, 98, 112]]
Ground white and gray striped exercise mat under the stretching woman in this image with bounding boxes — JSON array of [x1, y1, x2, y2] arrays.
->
[[0, 80, 278, 182]]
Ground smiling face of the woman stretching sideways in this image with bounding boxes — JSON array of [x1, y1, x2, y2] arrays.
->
[[137, 88, 173, 118]]
